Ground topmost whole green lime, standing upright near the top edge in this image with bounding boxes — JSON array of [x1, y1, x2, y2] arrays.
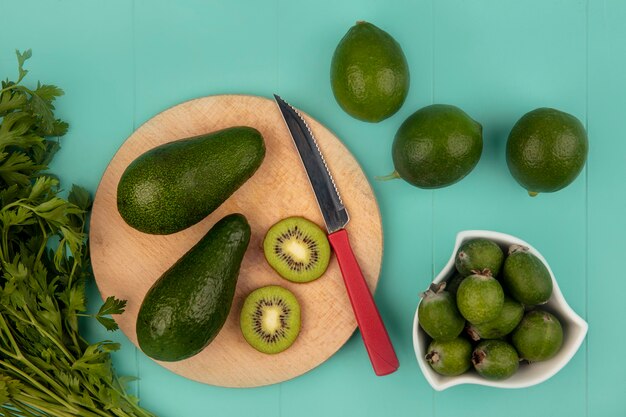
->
[[330, 21, 409, 122]]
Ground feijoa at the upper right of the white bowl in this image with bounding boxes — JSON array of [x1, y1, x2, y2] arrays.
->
[[500, 245, 552, 306]]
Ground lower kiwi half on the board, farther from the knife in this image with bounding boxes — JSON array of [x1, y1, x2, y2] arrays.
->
[[239, 285, 300, 353]]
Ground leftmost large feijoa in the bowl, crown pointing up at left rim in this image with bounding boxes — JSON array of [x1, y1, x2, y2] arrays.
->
[[417, 282, 465, 340]]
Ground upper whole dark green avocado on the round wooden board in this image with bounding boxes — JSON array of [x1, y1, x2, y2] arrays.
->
[[117, 126, 265, 235]]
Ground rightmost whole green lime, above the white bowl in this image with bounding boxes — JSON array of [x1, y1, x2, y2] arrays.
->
[[506, 108, 589, 196]]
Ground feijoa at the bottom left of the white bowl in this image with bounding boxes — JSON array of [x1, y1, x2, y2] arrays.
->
[[426, 337, 472, 376]]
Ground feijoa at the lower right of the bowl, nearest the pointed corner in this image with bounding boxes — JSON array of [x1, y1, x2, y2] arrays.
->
[[511, 310, 563, 362]]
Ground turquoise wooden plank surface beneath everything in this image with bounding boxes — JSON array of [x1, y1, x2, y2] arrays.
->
[[0, 0, 626, 417]]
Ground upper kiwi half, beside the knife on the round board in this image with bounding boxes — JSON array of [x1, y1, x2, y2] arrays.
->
[[263, 217, 330, 282]]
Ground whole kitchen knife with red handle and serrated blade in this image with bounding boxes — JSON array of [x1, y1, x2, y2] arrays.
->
[[274, 94, 399, 376]]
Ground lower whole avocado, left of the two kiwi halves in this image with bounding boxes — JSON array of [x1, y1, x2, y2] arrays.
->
[[136, 214, 250, 362]]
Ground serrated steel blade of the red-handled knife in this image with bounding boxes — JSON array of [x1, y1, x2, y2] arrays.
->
[[274, 94, 350, 233]]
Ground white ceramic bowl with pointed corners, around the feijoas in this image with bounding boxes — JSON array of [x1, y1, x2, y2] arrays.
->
[[413, 230, 588, 391]]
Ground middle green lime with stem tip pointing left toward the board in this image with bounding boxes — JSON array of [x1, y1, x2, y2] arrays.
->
[[380, 104, 483, 188]]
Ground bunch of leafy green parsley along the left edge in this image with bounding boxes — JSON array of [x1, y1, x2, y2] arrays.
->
[[0, 51, 152, 417]]
